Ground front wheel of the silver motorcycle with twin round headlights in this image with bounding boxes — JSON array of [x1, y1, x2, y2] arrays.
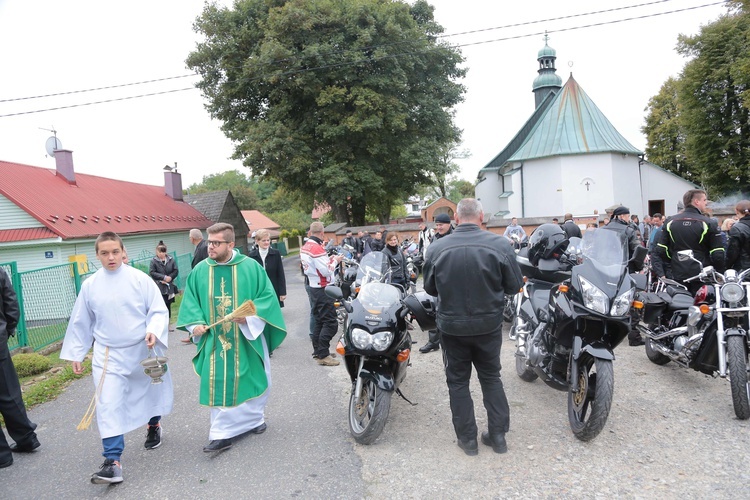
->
[[349, 380, 393, 444]]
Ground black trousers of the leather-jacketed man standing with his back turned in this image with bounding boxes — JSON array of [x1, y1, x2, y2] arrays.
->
[[440, 332, 510, 441]]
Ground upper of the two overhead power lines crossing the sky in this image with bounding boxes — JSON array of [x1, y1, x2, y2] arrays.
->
[[0, 0, 722, 103]]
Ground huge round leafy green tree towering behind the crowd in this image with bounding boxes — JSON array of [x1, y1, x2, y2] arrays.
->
[[187, 0, 465, 225]]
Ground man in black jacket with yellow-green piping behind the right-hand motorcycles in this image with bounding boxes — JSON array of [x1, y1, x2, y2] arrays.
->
[[652, 189, 725, 293]]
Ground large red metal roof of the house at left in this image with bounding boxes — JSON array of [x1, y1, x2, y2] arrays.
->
[[0, 161, 213, 241]]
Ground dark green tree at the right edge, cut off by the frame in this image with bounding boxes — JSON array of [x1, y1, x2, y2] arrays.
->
[[677, 7, 750, 195]]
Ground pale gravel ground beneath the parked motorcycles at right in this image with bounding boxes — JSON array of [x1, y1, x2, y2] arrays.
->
[[350, 320, 750, 499]]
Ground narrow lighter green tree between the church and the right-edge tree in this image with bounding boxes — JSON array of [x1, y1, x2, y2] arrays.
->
[[641, 77, 699, 182]]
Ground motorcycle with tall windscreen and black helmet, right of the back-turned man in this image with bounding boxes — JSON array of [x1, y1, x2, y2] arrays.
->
[[513, 224, 645, 441]]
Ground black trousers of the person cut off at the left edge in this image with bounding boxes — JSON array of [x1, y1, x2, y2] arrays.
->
[[0, 341, 36, 463]]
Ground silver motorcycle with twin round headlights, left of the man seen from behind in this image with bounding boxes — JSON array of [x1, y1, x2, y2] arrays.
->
[[326, 252, 435, 444]]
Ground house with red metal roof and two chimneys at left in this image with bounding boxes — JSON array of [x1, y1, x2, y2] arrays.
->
[[0, 150, 213, 271]]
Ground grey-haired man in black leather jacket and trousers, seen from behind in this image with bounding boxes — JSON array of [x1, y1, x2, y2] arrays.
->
[[424, 198, 523, 455]]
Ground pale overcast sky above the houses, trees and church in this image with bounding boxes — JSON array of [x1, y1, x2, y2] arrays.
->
[[0, 0, 726, 187]]
